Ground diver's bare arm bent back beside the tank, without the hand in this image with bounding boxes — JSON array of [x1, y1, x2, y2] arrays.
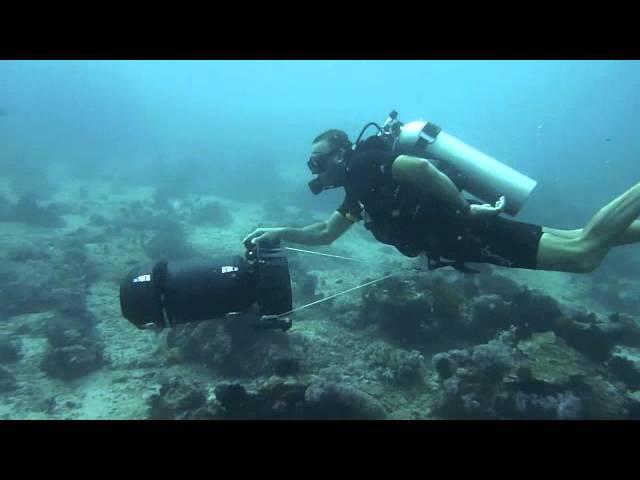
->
[[391, 155, 470, 215]]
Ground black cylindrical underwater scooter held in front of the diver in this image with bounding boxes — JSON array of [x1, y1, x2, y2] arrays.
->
[[120, 238, 292, 331]]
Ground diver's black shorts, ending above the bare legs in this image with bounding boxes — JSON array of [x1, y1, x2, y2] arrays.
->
[[430, 217, 543, 270]]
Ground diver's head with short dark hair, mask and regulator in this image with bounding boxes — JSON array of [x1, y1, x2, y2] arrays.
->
[[307, 129, 352, 195]]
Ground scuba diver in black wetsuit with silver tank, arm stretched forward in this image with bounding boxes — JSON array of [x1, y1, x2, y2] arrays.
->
[[243, 111, 640, 273]]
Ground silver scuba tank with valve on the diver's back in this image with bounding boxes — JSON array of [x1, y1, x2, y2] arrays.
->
[[354, 110, 537, 216]]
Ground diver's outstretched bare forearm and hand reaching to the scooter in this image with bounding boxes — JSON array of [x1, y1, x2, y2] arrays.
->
[[243, 212, 353, 245]]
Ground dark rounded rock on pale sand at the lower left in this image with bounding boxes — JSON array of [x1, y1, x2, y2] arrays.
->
[[41, 345, 103, 380]]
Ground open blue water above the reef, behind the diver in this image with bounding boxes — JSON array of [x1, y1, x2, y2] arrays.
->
[[0, 60, 640, 226]]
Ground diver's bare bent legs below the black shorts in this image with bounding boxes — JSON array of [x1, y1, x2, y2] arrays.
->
[[537, 183, 640, 273]]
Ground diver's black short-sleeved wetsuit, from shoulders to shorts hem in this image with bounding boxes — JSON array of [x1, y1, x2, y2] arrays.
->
[[337, 144, 542, 269]]
